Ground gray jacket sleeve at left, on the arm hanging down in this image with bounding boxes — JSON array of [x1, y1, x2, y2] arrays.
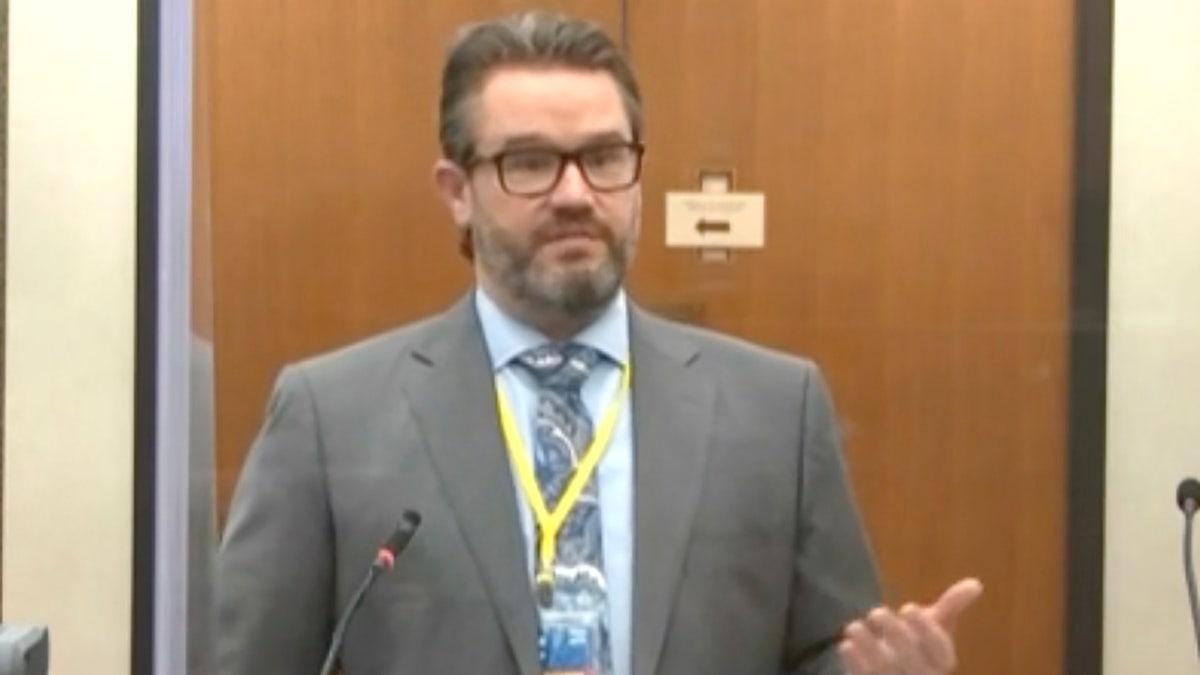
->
[[216, 369, 334, 675]]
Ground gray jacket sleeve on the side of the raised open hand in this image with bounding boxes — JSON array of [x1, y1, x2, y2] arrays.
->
[[785, 366, 880, 675]]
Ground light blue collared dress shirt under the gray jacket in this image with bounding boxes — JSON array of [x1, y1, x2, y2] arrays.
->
[[475, 289, 634, 675]]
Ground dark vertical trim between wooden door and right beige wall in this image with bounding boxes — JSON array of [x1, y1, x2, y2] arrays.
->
[[1063, 0, 1114, 675]]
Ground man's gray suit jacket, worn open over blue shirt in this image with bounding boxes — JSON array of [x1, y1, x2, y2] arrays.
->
[[217, 295, 878, 675]]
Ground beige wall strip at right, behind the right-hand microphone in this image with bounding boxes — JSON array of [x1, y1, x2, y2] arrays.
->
[[1104, 0, 1200, 675]]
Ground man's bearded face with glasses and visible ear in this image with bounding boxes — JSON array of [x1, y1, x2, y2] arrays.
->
[[438, 67, 641, 316]]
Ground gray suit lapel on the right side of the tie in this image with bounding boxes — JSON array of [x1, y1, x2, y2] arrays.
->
[[630, 309, 715, 675]]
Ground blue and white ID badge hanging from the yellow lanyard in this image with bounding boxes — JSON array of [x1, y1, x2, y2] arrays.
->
[[538, 562, 610, 675]]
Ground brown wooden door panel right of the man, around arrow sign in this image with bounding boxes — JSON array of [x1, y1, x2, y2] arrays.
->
[[628, 5, 1074, 675]]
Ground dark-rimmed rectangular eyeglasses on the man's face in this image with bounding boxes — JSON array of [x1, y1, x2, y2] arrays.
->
[[466, 142, 646, 197]]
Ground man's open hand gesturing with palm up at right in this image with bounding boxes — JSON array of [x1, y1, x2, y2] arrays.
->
[[838, 571, 983, 675]]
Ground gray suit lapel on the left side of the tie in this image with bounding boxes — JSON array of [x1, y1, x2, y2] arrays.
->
[[409, 297, 538, 675]]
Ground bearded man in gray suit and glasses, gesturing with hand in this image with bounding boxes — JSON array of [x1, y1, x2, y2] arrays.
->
[[218, 13, 980, 675]]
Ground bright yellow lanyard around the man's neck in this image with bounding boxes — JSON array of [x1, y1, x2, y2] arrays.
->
[[496, 365, 632, 604]]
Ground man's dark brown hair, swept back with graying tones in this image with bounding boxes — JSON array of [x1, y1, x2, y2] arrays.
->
[[439, 11, 644, 166]]
